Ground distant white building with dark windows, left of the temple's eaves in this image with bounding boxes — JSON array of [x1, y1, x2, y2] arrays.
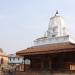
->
[[8, 54, 24, 71]]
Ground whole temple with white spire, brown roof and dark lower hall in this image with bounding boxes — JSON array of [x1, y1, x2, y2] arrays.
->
[[16, 11, 75, 75]]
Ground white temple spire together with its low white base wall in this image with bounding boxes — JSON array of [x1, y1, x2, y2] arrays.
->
[[34, 11, 75, 46]]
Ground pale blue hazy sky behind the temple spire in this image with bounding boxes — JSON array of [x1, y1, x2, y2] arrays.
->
[[0, 0, 75, 54]]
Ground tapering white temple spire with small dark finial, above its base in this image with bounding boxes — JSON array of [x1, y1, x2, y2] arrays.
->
[[47, 11, 68, 37]]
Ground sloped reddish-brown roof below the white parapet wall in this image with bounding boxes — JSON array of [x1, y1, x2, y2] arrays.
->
[[16, 42, 75, 56]]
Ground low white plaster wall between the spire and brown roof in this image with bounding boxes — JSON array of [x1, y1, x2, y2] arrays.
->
[[34, 35, 70, 46]]
